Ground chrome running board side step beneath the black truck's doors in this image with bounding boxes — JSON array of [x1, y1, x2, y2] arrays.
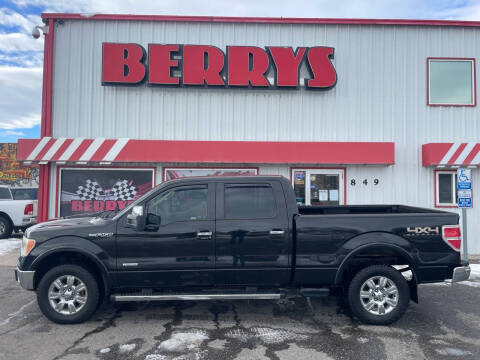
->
[[110, 292, 286, 302]]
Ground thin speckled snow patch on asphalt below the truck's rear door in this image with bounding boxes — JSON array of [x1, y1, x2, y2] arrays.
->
[[225, 327, 308, 344]]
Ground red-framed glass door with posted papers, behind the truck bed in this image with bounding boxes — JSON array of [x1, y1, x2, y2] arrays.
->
[[292, 169, 344, 205]]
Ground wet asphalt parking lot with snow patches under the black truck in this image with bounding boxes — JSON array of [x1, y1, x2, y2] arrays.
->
[[0, 239, 480, 360]]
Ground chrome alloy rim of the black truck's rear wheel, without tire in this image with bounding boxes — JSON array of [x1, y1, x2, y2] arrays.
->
[[360, 276, 398, 315]]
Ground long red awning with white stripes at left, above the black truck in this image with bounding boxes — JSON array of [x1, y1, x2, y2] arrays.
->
[[17, 137, 395, 165]]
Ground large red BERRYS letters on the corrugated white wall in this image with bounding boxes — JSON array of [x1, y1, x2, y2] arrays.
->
[[102, 43, 337, 89]]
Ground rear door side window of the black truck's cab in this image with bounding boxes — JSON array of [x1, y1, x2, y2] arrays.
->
[[225, 184, 277, 219]]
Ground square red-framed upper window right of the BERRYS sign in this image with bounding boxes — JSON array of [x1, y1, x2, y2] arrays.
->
[[427, 58, 476, 106]]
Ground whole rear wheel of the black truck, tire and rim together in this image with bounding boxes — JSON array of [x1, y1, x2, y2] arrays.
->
[[348, 265, 410, 325]]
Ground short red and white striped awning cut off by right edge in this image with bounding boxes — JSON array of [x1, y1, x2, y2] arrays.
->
[[422, 142, 480, 168]]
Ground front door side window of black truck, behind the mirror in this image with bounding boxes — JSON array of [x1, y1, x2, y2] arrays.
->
[[146, 186, 208, 225]]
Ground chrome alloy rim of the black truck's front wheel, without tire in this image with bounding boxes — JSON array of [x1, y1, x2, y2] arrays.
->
[[48, 275, 88, 315]]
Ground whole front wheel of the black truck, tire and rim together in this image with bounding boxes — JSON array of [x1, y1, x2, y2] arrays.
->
[[37, 265, 99, 324]]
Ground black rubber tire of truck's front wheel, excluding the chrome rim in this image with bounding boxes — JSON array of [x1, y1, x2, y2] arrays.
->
[[37, 265, 99, 324]]
